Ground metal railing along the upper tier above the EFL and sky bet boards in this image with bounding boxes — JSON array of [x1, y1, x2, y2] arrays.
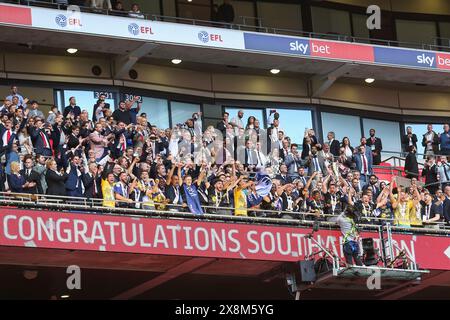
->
[[3, 0, 450, 51]]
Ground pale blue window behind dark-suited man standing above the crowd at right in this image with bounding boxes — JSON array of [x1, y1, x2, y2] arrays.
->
[[363, 119, 402, 158]]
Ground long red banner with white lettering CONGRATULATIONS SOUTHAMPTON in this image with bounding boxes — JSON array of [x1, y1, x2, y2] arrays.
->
[[0, 208, 450, 270]]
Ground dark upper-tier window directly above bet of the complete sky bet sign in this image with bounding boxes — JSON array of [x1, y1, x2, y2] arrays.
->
[[311, 7, 352, 36]]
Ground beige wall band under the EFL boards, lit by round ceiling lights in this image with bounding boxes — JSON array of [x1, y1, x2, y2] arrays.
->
[[0, 54, 450, 116]]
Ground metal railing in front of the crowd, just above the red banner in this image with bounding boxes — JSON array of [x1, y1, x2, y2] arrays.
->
[[0, 192, 450, 235]]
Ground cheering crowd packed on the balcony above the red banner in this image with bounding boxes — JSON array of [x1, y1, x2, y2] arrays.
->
[[0, 85, 450, 227]]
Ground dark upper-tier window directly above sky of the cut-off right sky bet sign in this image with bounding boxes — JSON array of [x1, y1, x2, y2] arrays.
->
[[395, 20, 436, 47]]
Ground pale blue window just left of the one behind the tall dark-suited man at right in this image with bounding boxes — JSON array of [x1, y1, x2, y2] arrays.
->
[[321, 112, 361, 147]]
